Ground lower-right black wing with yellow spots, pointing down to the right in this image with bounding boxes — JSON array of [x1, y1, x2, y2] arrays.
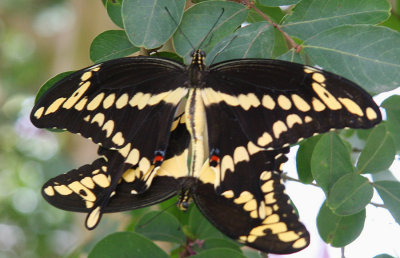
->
[[193, 149, 309, 254]]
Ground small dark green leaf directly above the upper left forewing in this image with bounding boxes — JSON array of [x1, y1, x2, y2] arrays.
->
[[90, 30, 140, 63]]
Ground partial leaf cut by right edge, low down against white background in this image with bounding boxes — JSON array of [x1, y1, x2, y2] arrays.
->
[[373, 181, 400, 224]]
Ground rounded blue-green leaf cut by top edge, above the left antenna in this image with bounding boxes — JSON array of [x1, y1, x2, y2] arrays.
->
[[122, 0, 185, 49]]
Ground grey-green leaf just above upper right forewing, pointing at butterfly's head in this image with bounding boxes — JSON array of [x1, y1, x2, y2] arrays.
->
[[206, 22, 275, 64]]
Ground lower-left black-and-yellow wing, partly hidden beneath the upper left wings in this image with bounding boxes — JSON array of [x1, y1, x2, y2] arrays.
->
[[42, 116, 190, 229]]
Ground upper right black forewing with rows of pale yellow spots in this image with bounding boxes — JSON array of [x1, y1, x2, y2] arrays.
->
[[202, 59, 381, 149]]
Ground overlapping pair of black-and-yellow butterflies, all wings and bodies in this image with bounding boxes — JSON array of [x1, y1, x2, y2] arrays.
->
[[31, 50, 382, 254]]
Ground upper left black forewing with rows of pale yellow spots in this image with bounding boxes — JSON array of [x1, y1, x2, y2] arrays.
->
[[31, 57, 187, 149]]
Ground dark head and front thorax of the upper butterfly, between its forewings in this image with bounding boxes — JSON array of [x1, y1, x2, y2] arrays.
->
[[188, 50, 206, 88]]
